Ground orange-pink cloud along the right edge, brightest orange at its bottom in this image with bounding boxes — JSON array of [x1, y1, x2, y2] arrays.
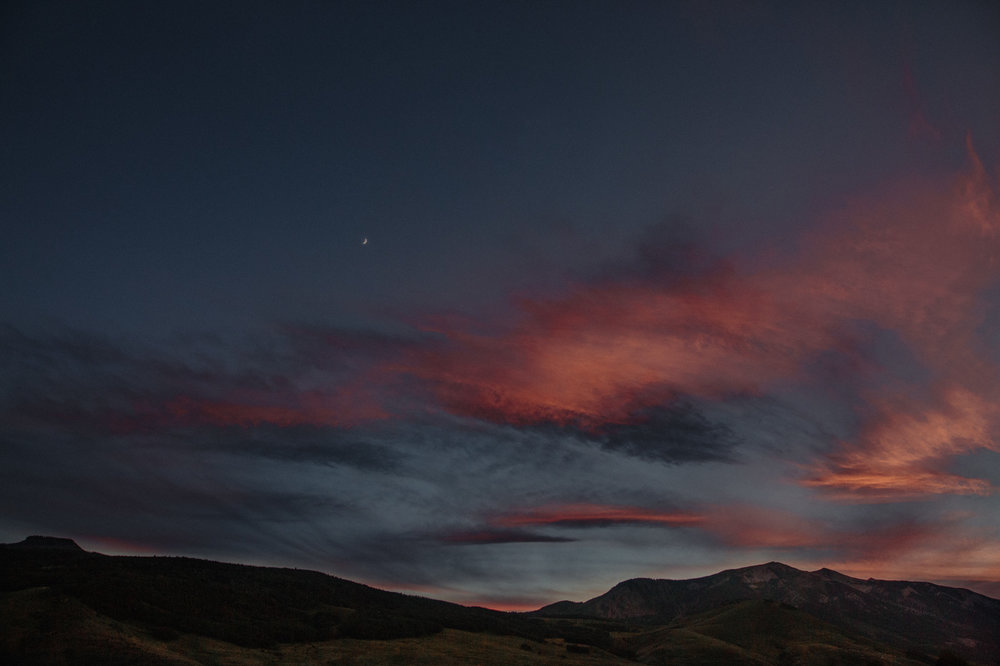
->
[[803, 145, 1000, 492]]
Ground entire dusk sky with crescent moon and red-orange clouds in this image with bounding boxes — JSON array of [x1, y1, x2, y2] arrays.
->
[[0, 0, 1000, 610]]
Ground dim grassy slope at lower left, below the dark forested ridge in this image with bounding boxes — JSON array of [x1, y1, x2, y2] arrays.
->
[[0, 588, 629, 666]]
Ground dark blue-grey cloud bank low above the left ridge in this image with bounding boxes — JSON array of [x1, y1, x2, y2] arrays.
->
[[0, 428, 352, 552]]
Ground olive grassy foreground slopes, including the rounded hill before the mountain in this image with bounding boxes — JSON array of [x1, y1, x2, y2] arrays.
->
[[0, 588, 960, 666]]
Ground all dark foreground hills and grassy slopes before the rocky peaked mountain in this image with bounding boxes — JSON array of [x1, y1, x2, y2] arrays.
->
[[0, 552, 972, 666]]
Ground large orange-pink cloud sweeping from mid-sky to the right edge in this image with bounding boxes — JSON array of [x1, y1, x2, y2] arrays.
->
[[396, 142, 1000, 500]]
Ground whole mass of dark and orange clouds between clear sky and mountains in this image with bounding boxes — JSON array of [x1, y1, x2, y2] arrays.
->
[[0, 141, 1000, 612]]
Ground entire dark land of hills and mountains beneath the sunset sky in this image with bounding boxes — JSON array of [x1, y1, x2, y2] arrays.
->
[[0, 537, 1000, 666]]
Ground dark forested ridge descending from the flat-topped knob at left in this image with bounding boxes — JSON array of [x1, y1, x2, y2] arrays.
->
[[0, 537, 612, 648]]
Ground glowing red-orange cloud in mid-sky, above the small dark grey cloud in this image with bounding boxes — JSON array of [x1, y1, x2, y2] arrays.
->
[[406, 264, 837, 427]]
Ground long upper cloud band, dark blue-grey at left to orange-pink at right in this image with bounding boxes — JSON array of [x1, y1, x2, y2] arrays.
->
[[9, 143, 1000, 501]]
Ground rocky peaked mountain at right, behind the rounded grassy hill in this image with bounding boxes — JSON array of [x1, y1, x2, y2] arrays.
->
[[534, 562, 1000, 663]]
